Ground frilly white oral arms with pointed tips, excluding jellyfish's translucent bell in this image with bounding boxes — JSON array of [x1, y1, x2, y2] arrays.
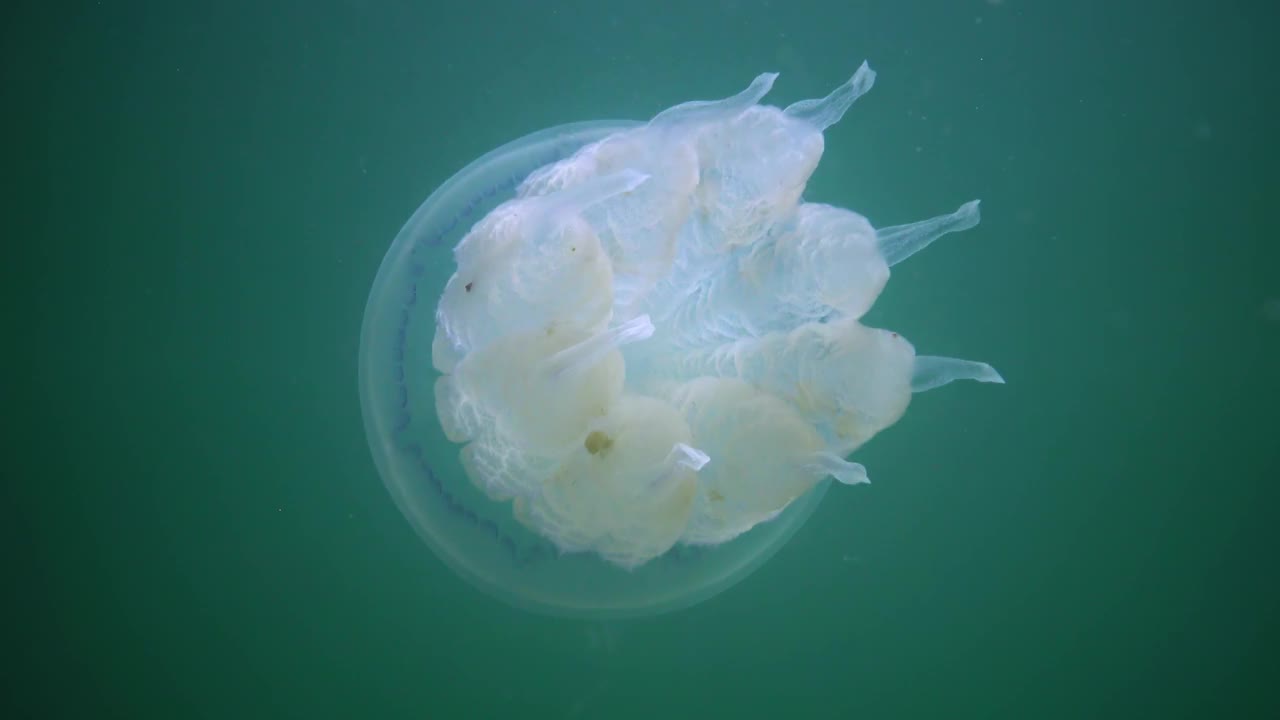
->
[[433, 64, 1004, 568]]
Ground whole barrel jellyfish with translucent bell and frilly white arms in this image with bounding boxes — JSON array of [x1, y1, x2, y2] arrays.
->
[[360, 63, 1004, 616]]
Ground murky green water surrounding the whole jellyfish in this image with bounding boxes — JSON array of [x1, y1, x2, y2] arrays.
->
[[0, 0, 1280, 719]]
